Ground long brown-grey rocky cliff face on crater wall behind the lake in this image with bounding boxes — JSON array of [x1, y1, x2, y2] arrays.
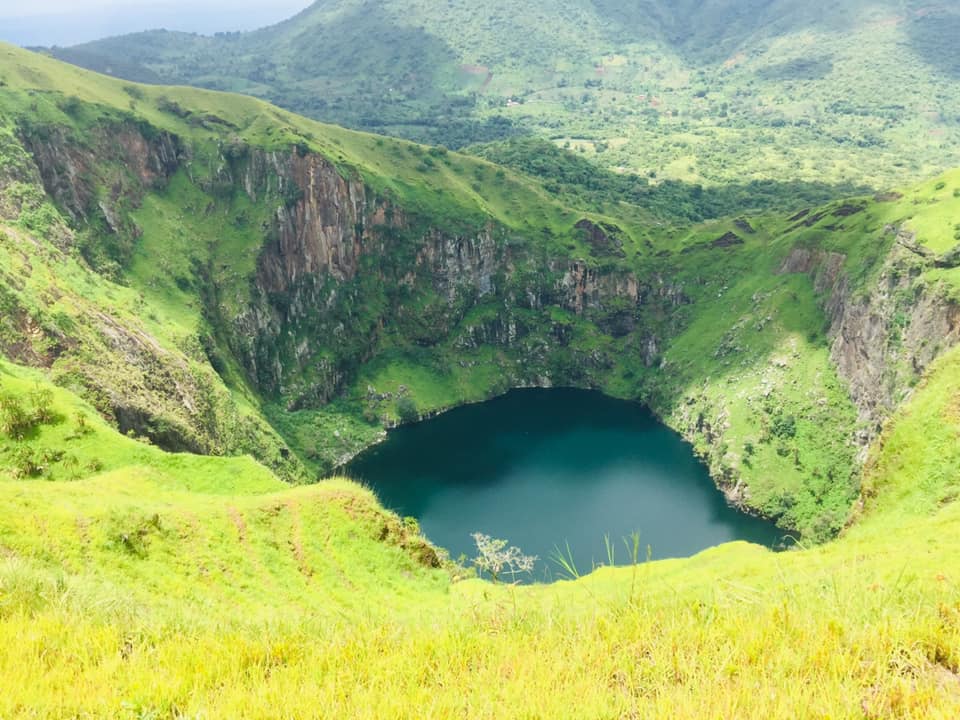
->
[[224, 150, 660, 408]]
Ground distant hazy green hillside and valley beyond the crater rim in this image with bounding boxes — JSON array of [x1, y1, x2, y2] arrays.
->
[[54, 0, 960, 188]]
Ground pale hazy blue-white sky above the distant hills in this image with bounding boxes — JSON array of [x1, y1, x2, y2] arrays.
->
[[0, 0, 312, 45]]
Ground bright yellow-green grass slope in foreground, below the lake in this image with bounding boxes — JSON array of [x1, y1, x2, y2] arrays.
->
[[0, 344, 960, 718]]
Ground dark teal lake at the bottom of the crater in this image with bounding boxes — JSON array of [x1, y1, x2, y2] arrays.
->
[[344, 389, 783, 579]]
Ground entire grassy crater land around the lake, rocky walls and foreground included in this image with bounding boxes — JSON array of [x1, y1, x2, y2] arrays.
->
[[0, 39, 960, 718]]
